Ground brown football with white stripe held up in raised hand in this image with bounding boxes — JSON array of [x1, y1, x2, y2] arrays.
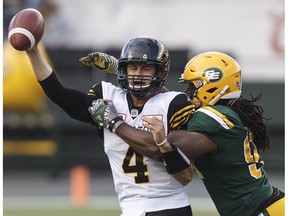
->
[[8, 8, 44, 51]]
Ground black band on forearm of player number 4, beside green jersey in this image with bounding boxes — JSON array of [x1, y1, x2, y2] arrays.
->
[[162, 144, 191, 174]]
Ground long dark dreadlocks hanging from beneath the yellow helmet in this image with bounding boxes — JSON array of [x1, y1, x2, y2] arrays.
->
[[227, 93, 270, 151]]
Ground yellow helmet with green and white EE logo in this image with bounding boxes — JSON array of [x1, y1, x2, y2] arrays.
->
[[178, 52, 242, 108]]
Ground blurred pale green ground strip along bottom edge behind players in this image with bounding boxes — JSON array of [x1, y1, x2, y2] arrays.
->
[[3, 196, 219, 216]]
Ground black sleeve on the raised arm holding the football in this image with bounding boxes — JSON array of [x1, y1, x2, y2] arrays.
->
[[39, 72, 98, 123]]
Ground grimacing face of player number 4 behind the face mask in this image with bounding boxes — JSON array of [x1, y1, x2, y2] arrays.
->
[[127, 62, 157, 88]]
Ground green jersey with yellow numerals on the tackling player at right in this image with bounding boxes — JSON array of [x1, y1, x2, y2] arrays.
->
[[188, 105, 273, 216]]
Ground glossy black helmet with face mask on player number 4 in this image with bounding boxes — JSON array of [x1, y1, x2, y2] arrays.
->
[[117, 37, 170, 97]]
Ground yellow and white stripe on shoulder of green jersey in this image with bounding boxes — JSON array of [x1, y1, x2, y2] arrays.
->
[[197, 106, 234, 129]]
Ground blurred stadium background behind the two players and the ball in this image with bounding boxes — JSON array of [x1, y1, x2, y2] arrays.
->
[[3, 0, 284, 216]]
